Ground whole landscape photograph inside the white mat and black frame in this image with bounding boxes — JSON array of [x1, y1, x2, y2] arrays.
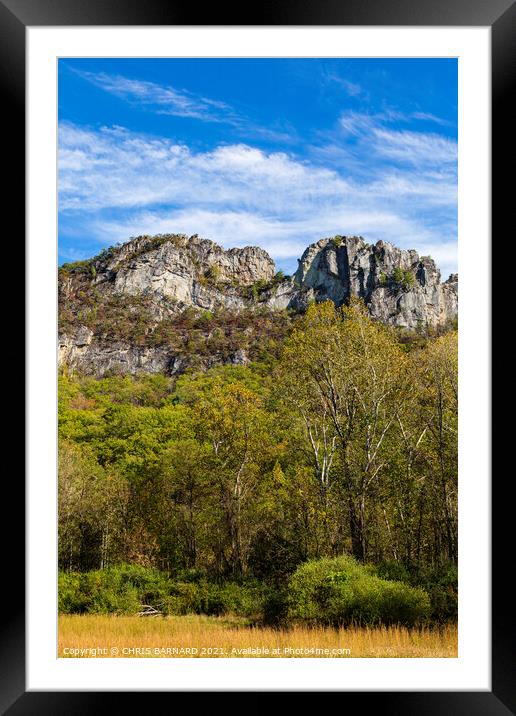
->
[[56, 57, 462, 659]]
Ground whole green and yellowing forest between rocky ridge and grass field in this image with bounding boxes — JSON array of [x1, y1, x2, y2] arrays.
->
[[58, 299, 458, 624]]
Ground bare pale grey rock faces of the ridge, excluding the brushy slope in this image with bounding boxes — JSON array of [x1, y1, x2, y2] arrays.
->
[[59, 235, 458, 375]]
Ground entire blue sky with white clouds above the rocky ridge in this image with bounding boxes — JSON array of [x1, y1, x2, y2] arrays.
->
[[59, 58, 457, 279]]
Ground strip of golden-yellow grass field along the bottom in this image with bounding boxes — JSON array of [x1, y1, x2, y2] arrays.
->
[[58, 615, 457, 658]]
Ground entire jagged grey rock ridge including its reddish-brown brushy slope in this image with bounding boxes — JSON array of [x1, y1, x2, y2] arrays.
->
[[59, 235, 458, 375]]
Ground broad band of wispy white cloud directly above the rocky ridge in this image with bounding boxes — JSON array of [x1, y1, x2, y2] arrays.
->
[[60, 123, 456, 273]]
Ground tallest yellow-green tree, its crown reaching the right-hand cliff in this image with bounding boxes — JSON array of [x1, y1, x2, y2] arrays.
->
[[283, 301, 410, 561]]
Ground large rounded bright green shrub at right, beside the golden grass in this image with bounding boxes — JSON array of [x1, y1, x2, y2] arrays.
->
[[288, 556, 430, 626]]
